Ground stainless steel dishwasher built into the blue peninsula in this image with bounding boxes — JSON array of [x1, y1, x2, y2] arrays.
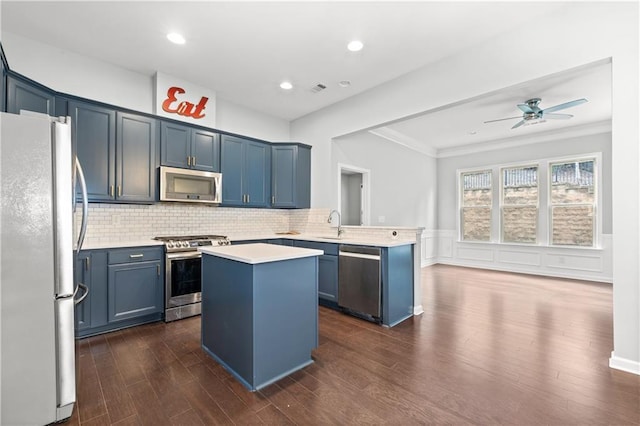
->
[[338, 245, 382, 323]]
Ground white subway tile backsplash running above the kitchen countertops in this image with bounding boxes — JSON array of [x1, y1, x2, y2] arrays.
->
[[76, 203, 416, 243]]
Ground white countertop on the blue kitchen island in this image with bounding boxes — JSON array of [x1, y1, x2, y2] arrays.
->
[[198, 243, 324, 264]]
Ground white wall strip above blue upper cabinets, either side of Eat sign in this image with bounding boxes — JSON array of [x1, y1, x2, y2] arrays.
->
[[2, 32, 290, 142]]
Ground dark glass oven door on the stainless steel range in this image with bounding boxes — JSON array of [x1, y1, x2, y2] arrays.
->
[[166, 251, 202, 308]]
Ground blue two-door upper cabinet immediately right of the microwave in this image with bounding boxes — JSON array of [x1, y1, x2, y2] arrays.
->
[[221, 135, 271, 207]]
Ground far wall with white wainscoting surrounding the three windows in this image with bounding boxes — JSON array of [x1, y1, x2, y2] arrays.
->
[[435, 132, 613, 282]]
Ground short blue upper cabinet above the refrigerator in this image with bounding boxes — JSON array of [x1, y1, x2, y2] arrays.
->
[[7, 74, 56, 115]]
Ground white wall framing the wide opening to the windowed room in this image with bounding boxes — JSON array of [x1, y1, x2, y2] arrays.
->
[[291, 2, 640, 374]]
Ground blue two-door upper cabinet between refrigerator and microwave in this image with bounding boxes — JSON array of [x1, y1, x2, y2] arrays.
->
[[68, 100, 159, 203]]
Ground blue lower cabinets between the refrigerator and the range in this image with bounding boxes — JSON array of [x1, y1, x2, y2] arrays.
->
[[75, 247, 164, 338]]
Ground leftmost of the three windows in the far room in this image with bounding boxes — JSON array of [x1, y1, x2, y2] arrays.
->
[[460, 170, 493, 241]]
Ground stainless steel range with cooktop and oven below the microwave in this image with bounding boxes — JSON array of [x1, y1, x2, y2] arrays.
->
[[155, 235, 230, 322]]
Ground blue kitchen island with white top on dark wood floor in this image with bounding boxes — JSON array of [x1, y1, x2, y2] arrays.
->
[[200, 243, 323, 391]]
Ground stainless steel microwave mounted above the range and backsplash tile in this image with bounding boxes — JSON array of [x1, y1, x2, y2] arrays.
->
[[160, 166, 222, 204]]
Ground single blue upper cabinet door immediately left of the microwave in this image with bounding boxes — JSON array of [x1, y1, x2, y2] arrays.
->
[[115, 112, 159, 203]]
